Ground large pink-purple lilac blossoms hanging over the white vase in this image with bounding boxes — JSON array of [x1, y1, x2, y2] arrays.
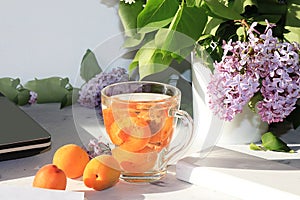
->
[[208, 23, 300, 123]]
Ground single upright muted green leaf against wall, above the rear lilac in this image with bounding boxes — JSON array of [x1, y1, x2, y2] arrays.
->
[[80, 49, 102, 82]]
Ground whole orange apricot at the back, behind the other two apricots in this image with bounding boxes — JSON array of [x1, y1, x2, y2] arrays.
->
[[52, 144, 90, 178]]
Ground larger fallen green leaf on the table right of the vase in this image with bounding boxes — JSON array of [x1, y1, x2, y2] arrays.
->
[[261, 132, 292, 152]]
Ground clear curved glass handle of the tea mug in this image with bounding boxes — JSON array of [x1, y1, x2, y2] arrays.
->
[[164, 110, 195, 166]]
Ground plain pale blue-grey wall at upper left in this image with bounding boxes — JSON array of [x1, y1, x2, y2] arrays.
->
[[0, 0, 121, 85]]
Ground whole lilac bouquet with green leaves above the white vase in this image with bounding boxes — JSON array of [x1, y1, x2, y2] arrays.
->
[[115, 0, 300, 150]]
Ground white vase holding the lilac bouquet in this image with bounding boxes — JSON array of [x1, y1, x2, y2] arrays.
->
[[192, 55, 268, 150]]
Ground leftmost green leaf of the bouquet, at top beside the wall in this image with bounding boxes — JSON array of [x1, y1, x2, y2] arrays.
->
[[118, 0, 145, 37]]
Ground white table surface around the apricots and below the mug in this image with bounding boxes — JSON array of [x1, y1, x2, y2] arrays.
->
[[0, 104, 239, 200]]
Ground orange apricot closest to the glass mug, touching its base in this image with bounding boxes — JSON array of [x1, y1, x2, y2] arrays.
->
[[83, 155, 121, 190]]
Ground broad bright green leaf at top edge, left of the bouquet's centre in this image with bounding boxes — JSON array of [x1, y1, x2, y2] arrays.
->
[[137, 0, 179, 33]]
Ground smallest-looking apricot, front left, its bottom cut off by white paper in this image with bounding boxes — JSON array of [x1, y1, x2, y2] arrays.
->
[[32, 164, 67, 190]]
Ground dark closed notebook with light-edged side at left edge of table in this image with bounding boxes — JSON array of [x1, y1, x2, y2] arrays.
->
[[0, 93, 51, 161]]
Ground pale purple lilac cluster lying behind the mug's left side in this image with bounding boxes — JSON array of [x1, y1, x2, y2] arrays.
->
[[78, 67, 129, 114]]
